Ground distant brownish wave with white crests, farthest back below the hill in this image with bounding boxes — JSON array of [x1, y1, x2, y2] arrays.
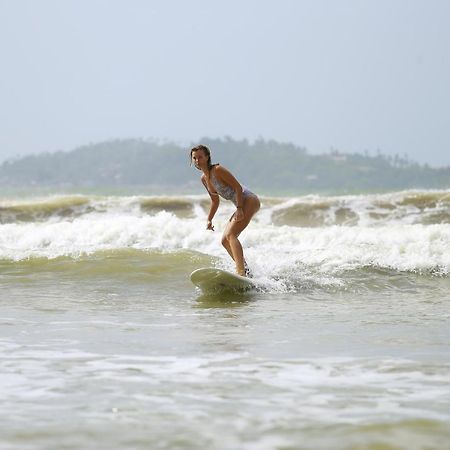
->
[[0, 190, 450, 228]]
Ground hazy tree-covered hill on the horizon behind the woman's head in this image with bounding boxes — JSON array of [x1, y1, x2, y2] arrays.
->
[[0, 138, 450, 192]]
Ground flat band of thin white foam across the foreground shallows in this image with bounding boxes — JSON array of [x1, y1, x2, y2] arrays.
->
[[0, 341, 450, 424]]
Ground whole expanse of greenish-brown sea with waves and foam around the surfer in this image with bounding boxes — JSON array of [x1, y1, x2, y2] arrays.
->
[[0, 191, 450, 450]]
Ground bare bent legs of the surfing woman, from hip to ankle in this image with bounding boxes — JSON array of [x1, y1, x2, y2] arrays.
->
[[222, 195, 260, 276]]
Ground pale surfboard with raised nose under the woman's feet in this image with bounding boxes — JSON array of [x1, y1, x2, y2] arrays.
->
[[191, 267, 256, 293]]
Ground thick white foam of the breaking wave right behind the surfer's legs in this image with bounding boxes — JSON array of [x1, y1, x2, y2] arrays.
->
[[0, 206, 450, 277]]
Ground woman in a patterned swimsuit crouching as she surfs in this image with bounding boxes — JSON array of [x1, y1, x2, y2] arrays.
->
[[190, 145, 260, 277]]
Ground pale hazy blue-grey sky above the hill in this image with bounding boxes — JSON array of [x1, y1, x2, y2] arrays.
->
[[0, 0, 450, 166]]
